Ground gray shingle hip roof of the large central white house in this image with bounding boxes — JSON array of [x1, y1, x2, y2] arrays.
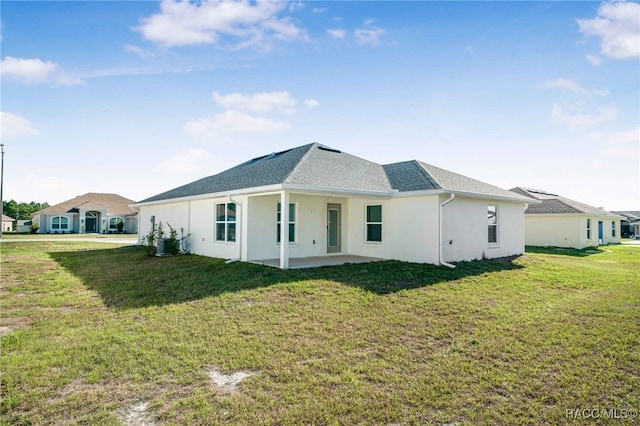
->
[[140, 143, 528, 203]]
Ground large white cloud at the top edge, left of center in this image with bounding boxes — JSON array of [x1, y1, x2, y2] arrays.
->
[[135, 0, 306, 48]]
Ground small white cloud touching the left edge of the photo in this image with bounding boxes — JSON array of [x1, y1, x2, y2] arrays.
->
[[0, 56, 83, 86]]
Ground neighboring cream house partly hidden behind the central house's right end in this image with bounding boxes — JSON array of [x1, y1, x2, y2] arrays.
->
[[511, 187, 623, 249]]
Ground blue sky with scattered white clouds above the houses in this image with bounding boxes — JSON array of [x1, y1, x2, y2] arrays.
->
[[0, 0, 640, 210]]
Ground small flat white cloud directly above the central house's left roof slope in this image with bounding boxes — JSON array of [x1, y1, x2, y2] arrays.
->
[[213, 91, 298, 114]]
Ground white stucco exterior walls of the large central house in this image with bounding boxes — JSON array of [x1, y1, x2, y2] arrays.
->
[[138, 193, 528, 264]]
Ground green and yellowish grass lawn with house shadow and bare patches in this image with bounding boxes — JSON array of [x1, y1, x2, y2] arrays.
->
[[0, 241, 640, 425]]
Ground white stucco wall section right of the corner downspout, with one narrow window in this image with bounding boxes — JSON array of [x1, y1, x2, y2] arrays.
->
[[443, 197, 524, 262]]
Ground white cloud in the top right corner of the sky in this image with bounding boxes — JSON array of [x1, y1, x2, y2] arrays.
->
[[578, 1, 640, 59]]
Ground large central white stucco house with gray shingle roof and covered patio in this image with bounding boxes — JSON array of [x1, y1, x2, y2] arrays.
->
[[133, 143, 535, 268]]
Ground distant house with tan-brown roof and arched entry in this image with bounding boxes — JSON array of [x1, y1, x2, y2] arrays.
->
[[32, 192, 138, 234]]
